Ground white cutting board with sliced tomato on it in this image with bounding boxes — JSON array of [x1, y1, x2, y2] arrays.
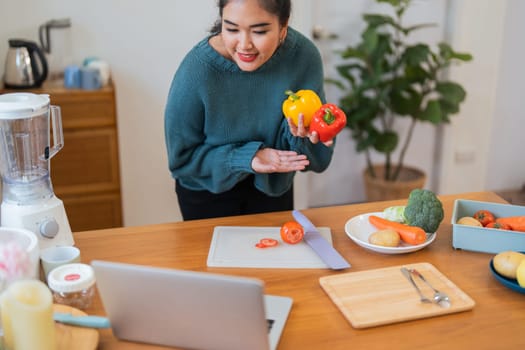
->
[[207, 226, 332, 269]]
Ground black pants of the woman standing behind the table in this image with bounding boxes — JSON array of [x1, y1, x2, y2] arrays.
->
[[175, 175, 293, 220]]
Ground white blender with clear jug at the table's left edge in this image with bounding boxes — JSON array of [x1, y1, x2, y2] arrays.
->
[[0, 93, 74, 249]]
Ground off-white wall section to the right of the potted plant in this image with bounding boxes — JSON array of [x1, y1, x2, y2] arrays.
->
[[440, 0, 525, 193]]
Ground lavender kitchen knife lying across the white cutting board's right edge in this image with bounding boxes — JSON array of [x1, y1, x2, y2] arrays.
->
[[292, 210, 350, 270]]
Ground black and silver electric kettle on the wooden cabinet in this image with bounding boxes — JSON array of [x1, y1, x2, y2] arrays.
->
[[4, 39, 47, 89]]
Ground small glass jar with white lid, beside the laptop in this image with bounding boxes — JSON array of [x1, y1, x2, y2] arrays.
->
[[47, 264, 95, 310]]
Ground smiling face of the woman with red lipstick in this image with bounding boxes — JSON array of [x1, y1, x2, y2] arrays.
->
[[221, 0, 286, 72]]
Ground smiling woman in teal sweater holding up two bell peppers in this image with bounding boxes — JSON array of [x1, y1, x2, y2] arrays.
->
[[165, 0, 333, 220]]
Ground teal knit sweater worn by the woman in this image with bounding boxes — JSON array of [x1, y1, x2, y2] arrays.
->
[[164, 28, 333, 196]]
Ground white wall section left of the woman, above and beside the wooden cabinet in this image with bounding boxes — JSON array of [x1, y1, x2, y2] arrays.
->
[[0, 0, 217, 226]]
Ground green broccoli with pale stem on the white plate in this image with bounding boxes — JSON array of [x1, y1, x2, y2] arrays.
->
[[383, 189, 444, 232]]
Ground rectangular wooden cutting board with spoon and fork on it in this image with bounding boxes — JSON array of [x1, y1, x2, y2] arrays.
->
[[319, 263, 475, 328]]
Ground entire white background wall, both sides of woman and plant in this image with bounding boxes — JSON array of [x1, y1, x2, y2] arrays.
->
[[0, 0, 525, 226]]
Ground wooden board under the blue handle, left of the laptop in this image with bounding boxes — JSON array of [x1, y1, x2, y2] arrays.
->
[[53, 304, 99, 350]]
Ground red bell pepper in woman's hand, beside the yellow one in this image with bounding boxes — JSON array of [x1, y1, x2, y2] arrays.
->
[[310, 103, 346, 142]]
